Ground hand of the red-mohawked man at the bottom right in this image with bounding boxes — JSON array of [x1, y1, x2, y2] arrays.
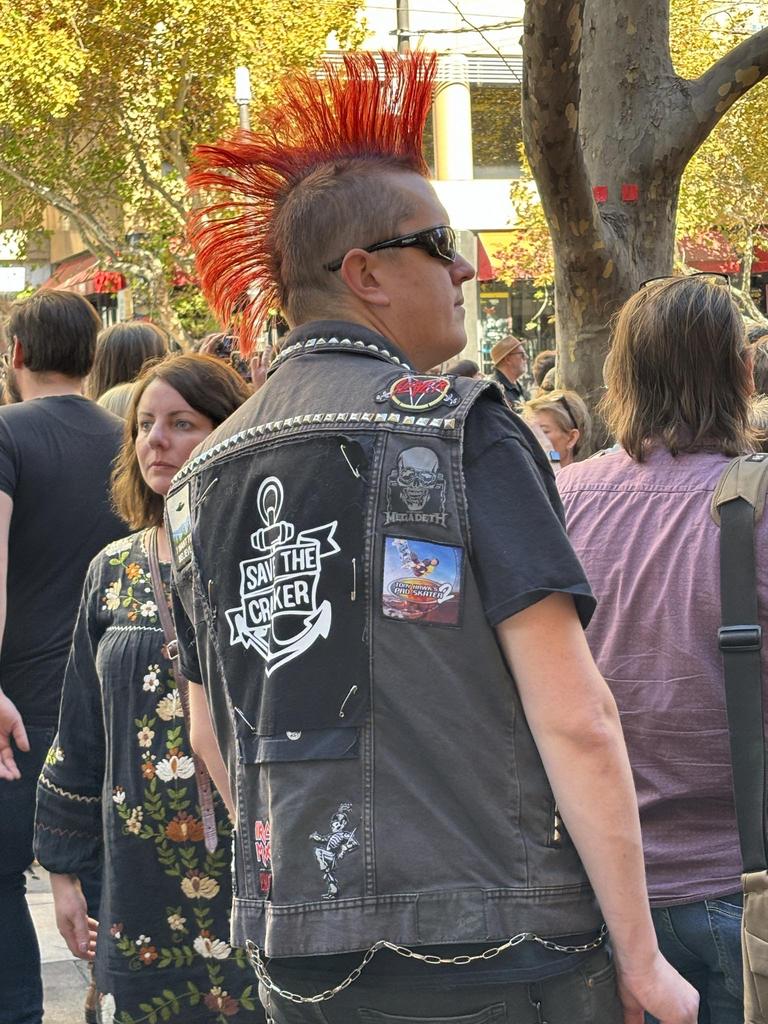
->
[[616, 953, 698, 1024]]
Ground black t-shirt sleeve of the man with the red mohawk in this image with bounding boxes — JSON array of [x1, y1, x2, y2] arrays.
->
[[464, 396, 596, 627]]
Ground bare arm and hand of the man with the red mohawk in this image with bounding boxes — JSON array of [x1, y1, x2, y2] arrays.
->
[[497, 594, 697, 1024]]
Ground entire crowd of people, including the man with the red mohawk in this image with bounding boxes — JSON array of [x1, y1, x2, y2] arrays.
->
[[0, 55, 768, 1024]]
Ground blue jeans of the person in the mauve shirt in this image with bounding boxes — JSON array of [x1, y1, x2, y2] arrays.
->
[[646, 892, 744, 1024]]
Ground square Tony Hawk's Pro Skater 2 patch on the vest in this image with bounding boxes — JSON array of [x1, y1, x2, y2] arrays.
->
[[381, 537, 464, 626]]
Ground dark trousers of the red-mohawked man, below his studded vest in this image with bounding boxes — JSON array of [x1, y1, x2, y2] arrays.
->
[[259, 949, 624, 1024]]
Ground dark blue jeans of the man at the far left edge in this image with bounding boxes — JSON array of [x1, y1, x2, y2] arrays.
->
[[0, 726, 55, 1024]]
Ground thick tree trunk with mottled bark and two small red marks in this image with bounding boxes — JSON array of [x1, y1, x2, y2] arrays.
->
[[522, 0, 768, 423]]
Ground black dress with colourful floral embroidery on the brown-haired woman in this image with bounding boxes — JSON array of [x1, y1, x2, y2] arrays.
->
[[36, 532, 263, 1024]]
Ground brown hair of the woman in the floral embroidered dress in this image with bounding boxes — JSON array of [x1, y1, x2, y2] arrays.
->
[[112, 355, 252, 529]]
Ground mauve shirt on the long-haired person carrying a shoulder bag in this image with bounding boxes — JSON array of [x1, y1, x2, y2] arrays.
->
[[558, 449, 768, 906]]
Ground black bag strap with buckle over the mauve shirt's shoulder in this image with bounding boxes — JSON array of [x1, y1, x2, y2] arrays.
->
[[712, 454, 768, 871]]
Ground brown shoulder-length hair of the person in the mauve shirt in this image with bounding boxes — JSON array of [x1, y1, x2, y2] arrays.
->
[[599, 275, 755, 462]]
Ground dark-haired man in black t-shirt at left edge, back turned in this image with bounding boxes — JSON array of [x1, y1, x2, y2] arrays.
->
[[0, 291, 126, 1024]]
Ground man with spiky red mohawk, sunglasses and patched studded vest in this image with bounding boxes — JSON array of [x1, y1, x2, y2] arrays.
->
[[179, 54, 697, 1024]]
